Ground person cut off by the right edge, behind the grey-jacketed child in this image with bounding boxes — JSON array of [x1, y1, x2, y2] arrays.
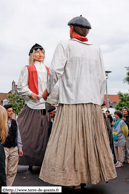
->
[[122, 107, 129, 164]]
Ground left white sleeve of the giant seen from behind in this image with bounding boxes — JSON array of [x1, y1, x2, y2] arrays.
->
[[47, 42, 67, 93]]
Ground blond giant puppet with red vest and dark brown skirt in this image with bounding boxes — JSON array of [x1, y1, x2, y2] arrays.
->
[[17, 44, 50, 169]]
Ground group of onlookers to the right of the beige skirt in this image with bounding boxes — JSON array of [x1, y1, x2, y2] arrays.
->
[[104, 107, 129, 168]]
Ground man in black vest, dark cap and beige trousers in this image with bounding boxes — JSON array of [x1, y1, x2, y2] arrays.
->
[[3, 104, 23, 186]]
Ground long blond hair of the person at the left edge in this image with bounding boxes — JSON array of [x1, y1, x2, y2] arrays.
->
[[0, 105, 8, 143]]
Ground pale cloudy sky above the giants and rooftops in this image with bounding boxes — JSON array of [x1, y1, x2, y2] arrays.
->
[[0, 0, 129, 94]]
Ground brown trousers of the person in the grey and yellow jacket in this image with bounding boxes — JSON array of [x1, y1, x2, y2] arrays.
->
[[114, 146, 124, 163]]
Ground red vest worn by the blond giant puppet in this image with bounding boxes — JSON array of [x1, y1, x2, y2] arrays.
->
[[27, 65, 49, 95]]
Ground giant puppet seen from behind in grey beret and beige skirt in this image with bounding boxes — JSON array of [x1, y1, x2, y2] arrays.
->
[[40, 16, 116, 190]]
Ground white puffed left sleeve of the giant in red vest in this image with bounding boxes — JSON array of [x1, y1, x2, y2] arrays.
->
[[17, 66, 32, 100]]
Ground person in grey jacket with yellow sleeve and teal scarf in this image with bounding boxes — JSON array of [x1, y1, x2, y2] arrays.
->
[[112, 110, 128, 168]]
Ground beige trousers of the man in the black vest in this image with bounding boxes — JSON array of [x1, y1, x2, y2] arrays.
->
[[4, 146, 19, 186]]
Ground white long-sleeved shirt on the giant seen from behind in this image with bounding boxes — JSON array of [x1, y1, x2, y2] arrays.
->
[[47, 39, 106, 105]]
